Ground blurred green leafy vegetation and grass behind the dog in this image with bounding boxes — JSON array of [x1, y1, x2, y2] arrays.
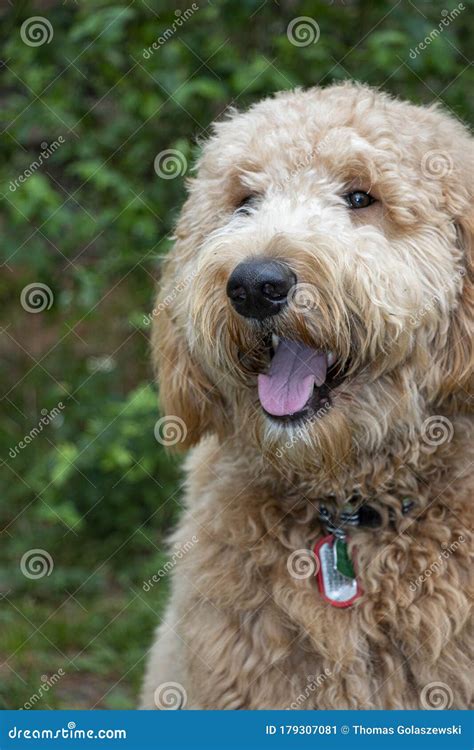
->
[[0, 0, 473, 708]]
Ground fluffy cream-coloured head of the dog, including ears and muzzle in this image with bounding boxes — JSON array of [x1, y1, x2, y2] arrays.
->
[[154, 84, 473, 470]]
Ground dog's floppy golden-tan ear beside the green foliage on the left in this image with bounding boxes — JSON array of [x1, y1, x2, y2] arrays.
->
[[151, 250, 226, 450]]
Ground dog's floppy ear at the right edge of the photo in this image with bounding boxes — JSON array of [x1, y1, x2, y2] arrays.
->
[[438, 210, 474, 413]]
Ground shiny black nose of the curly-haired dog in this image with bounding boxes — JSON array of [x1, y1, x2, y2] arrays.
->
[[227, 258, 296, 320]]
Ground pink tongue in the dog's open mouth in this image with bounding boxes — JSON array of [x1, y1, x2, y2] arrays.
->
[[258, 339, 327, 417]]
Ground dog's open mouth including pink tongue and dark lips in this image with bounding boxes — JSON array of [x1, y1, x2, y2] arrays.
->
[[258, 335, 343, 423]]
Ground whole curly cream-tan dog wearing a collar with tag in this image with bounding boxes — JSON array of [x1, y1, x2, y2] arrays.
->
[[141, 82, 474, 709]]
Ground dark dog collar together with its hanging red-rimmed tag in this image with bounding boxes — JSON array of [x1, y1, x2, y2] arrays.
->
[[314, 498, 415, 607]]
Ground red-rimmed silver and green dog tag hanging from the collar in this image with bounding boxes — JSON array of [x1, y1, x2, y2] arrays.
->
[[314, 534, 362, 607]]
